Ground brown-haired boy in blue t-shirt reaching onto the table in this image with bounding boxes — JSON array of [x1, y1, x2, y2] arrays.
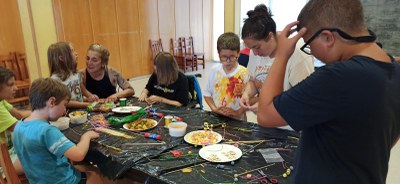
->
[[12, 78, 99, 183]]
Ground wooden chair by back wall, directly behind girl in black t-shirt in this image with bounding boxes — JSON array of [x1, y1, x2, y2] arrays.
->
[[169, 38, 194, 73]]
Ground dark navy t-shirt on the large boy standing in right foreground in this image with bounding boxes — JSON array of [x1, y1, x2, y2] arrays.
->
[[274, 56, 400, 184]]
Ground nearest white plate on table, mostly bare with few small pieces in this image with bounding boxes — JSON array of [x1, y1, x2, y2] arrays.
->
[[199, 144, 242, 163]]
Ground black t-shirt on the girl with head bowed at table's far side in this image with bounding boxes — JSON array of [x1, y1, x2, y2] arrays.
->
[[146, 72, 189, 106]]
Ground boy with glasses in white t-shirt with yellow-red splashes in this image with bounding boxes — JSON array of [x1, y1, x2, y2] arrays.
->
[[204, 33, 250, 120]]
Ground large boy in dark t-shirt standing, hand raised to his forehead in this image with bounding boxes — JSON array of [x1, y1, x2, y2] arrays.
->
[[257, 0, 400, 183]]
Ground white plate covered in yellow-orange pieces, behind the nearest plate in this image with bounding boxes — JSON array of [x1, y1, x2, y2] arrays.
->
[[184, 130, 222, 145]]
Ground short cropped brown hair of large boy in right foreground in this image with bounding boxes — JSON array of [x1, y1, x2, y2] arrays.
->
[[297, 0, 368, 36]]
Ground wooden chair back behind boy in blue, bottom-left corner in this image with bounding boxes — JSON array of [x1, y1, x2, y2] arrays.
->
[[0, 142, 21, 184]]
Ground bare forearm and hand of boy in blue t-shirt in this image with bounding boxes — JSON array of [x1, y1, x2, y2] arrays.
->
[[64, 131, 99, 162]]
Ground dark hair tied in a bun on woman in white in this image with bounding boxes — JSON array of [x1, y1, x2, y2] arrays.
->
[[242, 4, 276, 40]]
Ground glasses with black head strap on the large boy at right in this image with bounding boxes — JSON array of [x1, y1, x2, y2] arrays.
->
[[300, 28, 376, 55]]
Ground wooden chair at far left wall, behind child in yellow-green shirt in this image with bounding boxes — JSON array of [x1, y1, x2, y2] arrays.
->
[[0, 52, 31, 104]]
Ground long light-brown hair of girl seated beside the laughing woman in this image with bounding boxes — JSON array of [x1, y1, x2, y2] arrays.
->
[[47, 41, 77, 81]]
